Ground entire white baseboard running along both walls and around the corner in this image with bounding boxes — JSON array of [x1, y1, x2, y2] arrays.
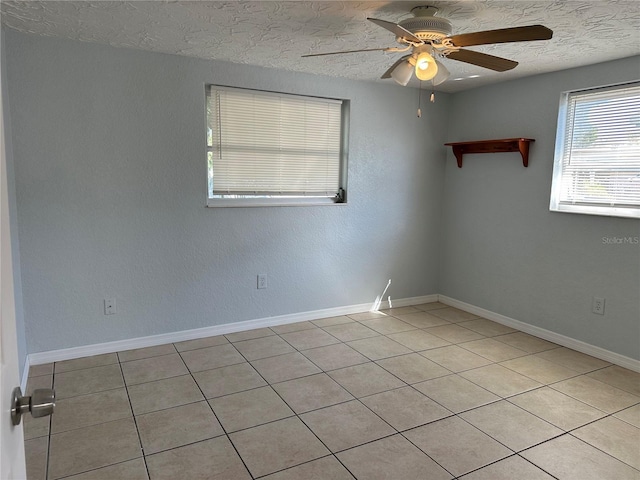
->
[[22, 294, 640, 374]]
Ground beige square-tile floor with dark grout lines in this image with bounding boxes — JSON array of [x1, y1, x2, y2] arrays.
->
[[25, 303, 640, 480]]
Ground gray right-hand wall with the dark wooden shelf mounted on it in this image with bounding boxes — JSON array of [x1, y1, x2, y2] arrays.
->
[[439, 57, 640, 359]]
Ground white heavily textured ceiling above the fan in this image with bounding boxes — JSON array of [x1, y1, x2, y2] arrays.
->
[[0, 0, 640, 92]]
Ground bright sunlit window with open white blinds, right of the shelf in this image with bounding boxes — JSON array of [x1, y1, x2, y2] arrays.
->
[[550, 82, 640, 217]]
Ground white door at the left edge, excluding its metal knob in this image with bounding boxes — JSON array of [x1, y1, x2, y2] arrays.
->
[[0, 58, 27, 480]]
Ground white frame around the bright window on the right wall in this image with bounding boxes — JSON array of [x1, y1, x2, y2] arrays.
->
[[549, 80, 640, 218]]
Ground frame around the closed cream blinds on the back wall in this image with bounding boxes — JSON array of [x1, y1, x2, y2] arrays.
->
[[204, 84, 350, 207]]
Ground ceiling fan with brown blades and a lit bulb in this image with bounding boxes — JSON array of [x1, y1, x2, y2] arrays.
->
[[302, 6, 553, 86]]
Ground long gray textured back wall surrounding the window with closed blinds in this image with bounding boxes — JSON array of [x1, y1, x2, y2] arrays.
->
[[6, 31, 449, 353]]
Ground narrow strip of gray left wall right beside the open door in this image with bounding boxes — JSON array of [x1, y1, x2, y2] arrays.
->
[[0, 25, 27, 378]]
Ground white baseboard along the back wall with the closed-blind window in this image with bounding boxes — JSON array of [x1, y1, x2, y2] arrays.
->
[[25, 295, 438, 371]]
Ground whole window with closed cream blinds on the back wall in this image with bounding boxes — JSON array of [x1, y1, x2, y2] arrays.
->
[[207, 85, 348, 206]]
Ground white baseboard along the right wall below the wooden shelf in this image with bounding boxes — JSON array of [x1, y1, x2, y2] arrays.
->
[[438, 295, 640, 372]]
